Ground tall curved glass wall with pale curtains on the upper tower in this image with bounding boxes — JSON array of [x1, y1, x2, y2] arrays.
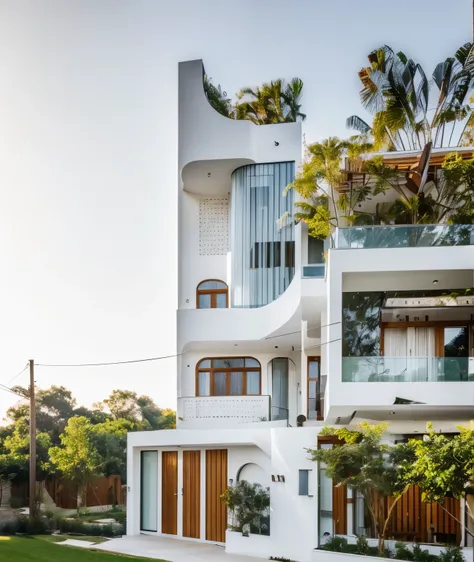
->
[[231, 162, 295, 308]]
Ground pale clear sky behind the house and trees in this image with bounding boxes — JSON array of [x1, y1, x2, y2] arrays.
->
[[0, 0, 472, 418]]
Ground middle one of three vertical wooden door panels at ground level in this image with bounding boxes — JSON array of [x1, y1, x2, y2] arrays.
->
[[183, 451, 201, 539]]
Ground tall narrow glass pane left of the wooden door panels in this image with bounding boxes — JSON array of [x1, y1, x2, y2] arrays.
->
[[140, 451, 158, 532]]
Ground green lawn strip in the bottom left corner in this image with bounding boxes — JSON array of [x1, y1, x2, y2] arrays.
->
[[0, 536, 163, 562]]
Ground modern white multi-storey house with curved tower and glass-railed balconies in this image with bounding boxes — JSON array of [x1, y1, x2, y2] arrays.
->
[[127, 60, 474, 562]]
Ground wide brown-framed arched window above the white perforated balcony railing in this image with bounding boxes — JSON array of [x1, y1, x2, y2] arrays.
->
[[196, 357, 261, 396]]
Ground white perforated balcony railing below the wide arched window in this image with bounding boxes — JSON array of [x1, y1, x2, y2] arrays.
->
[[178, 396, 270, 422]]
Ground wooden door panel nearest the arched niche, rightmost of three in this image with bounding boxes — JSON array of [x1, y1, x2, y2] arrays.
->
[[206, 449, 227, 542]]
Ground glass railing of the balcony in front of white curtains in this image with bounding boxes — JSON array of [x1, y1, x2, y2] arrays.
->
[[342, 357, 474, 382]]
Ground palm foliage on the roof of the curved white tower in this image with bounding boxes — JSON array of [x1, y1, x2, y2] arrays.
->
[[235, 78, 306, 125]]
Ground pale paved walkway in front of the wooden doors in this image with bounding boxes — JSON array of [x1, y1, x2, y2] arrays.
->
[[93, 535, 263, 562]]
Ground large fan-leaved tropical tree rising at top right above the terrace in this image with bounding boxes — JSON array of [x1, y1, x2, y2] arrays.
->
[[347, 43, 474, 150]]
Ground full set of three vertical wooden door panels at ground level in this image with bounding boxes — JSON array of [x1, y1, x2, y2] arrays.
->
[[161, 449, 227, 542]]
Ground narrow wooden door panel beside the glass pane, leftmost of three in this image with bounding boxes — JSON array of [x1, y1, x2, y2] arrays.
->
[[161, 451, 178, 535]]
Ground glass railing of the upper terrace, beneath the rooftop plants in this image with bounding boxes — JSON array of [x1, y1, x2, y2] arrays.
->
[[335, 224, 474, 250]]
